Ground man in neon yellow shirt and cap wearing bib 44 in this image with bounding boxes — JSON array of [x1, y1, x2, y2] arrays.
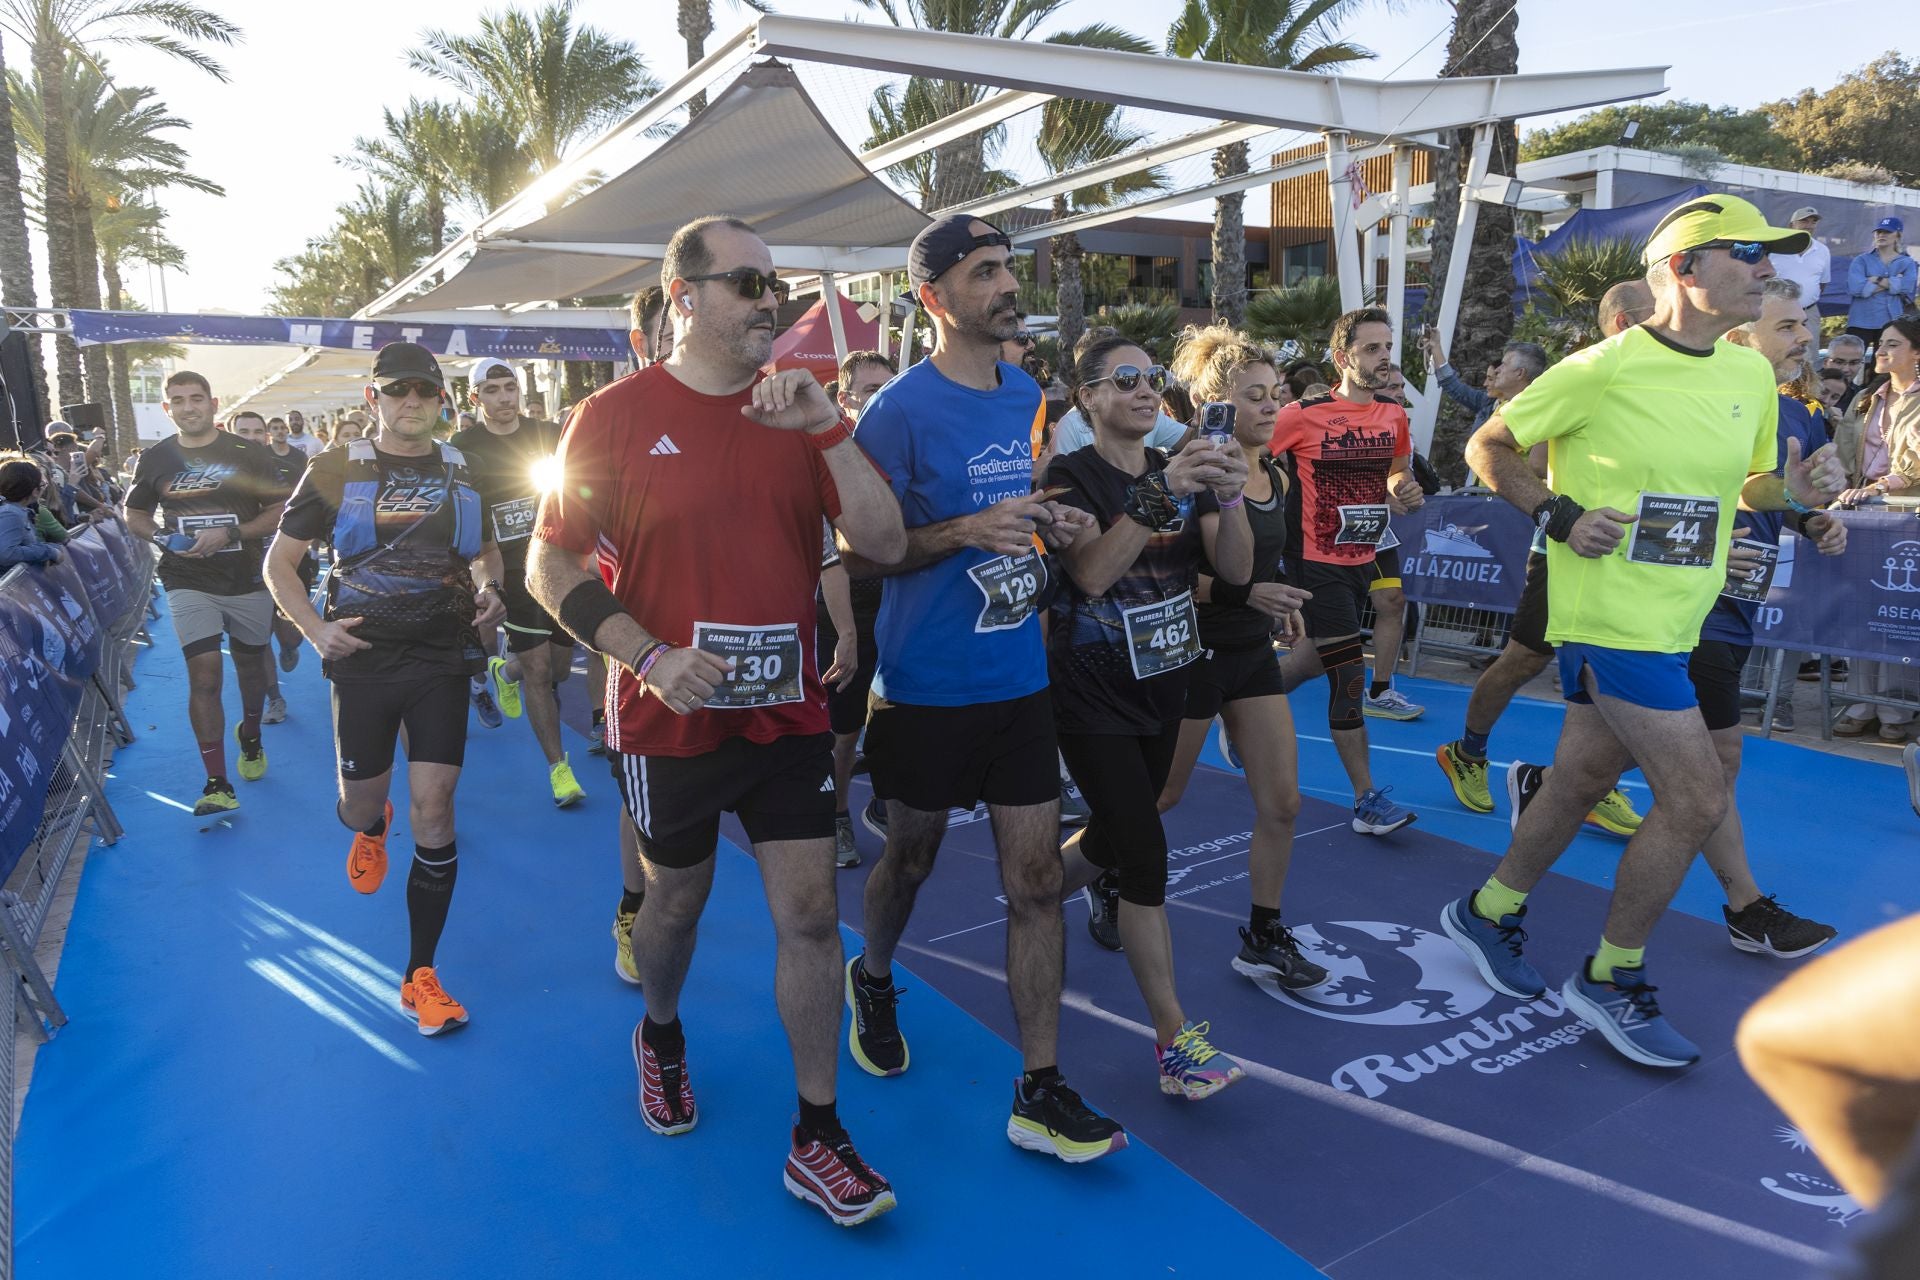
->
[[1440, 194, 1843, 1067]]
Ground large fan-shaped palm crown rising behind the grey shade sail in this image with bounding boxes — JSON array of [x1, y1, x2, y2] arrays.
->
[[410, 0, 660, 173]]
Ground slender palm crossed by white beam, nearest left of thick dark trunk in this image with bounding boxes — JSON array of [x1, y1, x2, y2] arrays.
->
[[1167, 0, 1373, 324]]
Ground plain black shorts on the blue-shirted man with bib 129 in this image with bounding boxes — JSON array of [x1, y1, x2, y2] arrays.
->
[[866, 689, 1060, 814]]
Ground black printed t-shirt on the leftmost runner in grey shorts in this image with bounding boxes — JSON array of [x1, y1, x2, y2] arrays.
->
[[127, 432, 286, 595]]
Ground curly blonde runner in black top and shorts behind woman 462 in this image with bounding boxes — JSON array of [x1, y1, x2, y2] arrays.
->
[[1144, 324, 1327, 990]]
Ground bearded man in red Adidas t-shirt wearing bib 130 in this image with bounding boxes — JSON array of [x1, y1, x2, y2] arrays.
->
[[528, 219, 906, 1224]]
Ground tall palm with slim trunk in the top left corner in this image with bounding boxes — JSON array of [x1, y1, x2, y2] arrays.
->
[[0, 0, 240, 412]]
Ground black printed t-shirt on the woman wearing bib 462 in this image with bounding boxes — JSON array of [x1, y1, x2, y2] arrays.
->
[[1041, 445, 1219, 737]]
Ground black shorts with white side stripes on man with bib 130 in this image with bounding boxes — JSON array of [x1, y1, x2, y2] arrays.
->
[[607, 733, 833, 867]]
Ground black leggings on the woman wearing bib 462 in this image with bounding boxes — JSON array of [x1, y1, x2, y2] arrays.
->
[[1060, 720, 1181, 906]]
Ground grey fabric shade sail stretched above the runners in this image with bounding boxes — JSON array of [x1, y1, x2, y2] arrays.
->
[[386, 61, 927, 315]]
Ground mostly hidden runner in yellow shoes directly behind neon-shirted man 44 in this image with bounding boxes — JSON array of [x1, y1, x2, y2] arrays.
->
[[1434, 280, 1653, 835]]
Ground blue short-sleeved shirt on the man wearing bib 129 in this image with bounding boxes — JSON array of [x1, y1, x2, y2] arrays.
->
[[858, 361, 1046, 706]]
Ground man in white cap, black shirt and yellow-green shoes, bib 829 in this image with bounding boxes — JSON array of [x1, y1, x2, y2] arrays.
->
[[453, 355, 586, 808]]
